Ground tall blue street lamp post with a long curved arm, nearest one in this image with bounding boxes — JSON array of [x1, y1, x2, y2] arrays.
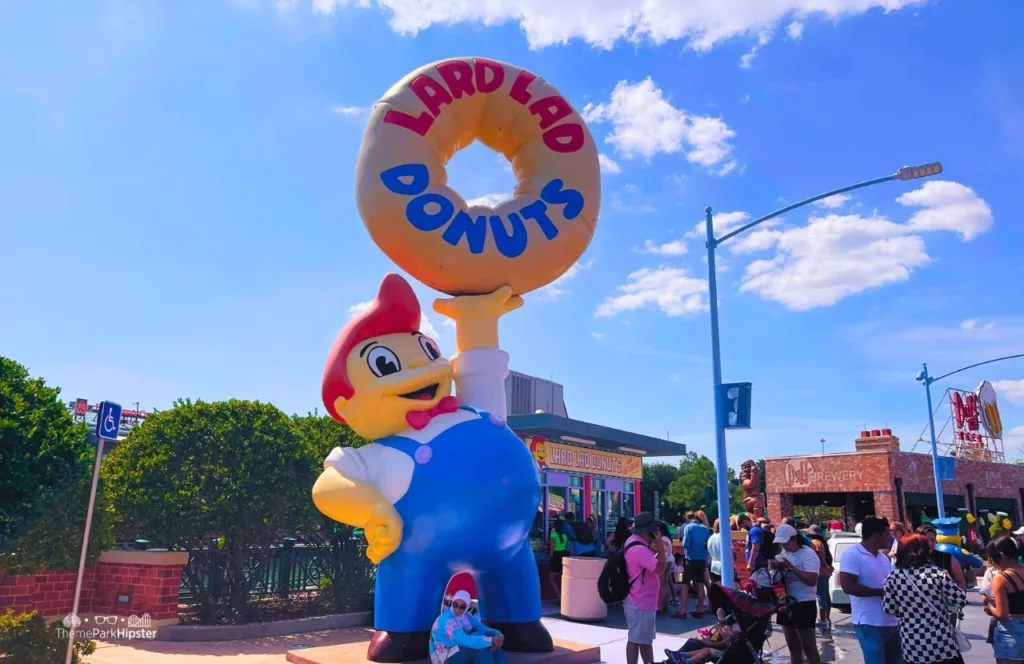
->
[[705, 162, 942, 588]]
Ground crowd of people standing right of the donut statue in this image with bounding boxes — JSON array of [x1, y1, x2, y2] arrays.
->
[[593, 512, 1024, 664]]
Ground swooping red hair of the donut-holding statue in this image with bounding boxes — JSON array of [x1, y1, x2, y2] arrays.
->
[[322, 274, 421, 422]]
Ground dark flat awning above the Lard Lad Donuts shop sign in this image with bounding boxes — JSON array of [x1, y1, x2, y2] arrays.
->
[[508, 413, 686, 456]]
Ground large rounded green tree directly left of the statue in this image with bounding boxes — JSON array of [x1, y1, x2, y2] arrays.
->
[[103, 400, 316, 622]]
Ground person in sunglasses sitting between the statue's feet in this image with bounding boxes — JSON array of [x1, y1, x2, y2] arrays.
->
[[430, 590, 505, 664]]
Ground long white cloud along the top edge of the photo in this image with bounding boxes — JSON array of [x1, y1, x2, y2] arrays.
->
[[301, 0, 928, 51]]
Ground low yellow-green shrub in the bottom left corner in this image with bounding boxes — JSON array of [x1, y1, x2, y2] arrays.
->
[[0, 609, 96, 664]]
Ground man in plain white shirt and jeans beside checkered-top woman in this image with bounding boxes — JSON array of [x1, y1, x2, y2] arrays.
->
[[839, 516, 903, 664]]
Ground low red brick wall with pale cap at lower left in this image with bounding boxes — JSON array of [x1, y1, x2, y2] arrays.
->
[[0, 551, 188, 620]]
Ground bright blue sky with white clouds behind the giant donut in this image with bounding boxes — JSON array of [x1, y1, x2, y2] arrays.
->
[[0, 0, 1024, 464]]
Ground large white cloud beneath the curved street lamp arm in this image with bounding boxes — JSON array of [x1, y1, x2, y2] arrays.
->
[[733, 181, 992, 313]]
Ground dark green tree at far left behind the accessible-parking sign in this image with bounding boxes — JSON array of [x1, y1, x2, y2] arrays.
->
[[0, 357, 113, 574]]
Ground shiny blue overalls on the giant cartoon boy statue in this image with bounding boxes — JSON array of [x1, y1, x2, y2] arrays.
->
[[374, 407, 541, 632]]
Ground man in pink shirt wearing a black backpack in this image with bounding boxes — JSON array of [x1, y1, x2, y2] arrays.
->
[[597, 511, 671, 664]]
